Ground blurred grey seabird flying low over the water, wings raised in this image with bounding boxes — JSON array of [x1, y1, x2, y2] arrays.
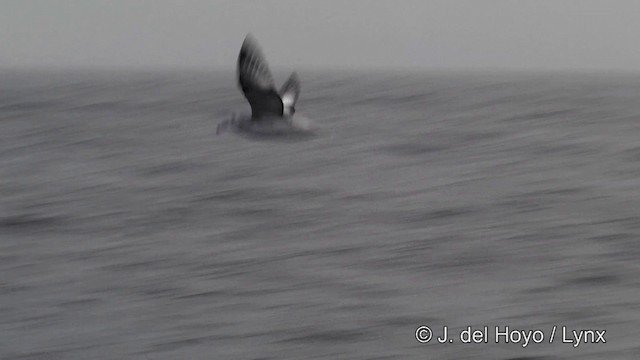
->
[[217, 35, 313, 134]]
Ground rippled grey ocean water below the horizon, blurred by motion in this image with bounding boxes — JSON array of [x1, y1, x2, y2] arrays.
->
[[0, 71, 640, 360]]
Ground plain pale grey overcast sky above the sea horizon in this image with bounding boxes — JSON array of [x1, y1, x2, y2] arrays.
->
[[0, 0, 640, 71]]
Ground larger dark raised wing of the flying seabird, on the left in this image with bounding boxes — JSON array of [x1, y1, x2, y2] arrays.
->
[[238, 35, 283, 119]]
